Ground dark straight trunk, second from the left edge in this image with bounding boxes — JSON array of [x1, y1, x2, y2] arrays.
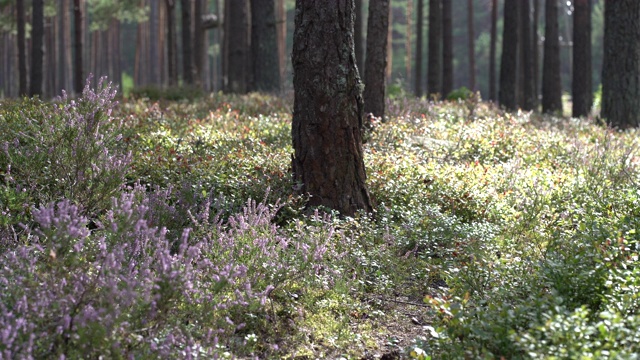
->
[[29, 0, 44, 96]]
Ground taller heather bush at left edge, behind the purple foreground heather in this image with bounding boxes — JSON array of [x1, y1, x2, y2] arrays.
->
[[0, 78, 131, 238]]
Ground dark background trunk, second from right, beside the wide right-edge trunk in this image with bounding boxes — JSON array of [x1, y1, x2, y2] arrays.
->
[[571, 0, 593, 117]]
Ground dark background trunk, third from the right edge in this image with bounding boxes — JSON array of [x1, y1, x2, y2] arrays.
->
[[542, 0, 564, 113]]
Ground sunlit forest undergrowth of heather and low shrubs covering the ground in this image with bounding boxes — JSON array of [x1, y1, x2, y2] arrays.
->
[[0, 83, 640, 359]]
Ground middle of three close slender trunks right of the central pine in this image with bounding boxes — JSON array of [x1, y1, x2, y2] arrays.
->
[[427, 0, 442, 96]]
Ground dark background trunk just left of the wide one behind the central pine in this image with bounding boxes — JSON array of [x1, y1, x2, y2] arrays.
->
[[225, 0, 251, 94]]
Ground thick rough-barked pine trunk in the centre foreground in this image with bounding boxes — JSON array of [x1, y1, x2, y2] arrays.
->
[[292, 0, 372, 215]]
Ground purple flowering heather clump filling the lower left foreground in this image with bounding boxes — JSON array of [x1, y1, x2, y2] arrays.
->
[[0, 184, 335, 359]]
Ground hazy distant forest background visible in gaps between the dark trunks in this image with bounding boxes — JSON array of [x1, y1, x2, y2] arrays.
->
[[0, 0, 604, 98]]
